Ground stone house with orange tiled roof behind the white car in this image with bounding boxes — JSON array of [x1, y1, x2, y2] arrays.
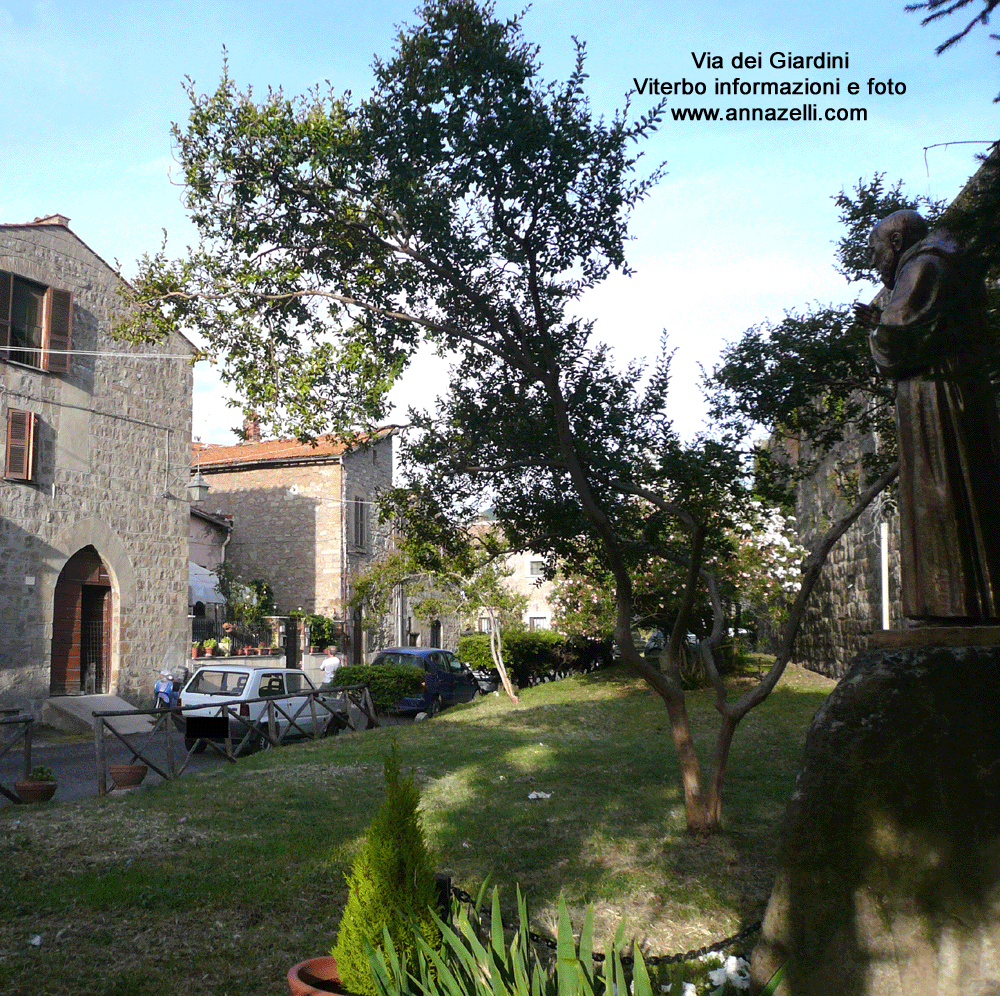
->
[[195, 426, 398, 663]]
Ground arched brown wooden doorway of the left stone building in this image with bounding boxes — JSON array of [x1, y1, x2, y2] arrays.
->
[[49, 546, 112, 695]]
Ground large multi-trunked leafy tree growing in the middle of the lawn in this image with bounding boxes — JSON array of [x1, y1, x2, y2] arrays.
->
[[117, 0, 976, 829]]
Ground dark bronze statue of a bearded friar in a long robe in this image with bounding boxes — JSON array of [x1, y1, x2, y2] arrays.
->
[[871, 232, 1000, 624]]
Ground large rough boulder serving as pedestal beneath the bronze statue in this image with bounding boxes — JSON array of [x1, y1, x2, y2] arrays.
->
[[753, 646, 1000, 996]]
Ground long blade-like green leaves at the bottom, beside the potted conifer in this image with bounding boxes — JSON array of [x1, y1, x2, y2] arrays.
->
[[368, 889, 653, 996]]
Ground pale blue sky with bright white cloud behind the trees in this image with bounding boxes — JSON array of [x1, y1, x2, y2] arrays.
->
[[0, 0, 1000, 442]]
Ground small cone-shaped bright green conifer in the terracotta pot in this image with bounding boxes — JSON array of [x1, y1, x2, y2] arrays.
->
[[331, 743, 441, 996]]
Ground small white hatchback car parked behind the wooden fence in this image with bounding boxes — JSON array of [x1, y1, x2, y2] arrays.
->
[[174, 664, 347, 752]]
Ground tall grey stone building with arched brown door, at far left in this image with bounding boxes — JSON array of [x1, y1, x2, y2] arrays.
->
[[0, 215, 194, 715]]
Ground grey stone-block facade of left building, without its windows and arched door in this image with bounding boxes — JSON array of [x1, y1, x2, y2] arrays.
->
[[0, 224, 193, 715]]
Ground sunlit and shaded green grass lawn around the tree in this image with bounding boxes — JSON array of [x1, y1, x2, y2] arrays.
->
[[0, 667, 833, 996]]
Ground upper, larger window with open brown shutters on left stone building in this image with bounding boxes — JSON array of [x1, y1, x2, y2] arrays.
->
[[0, 270, 73, 373]]
